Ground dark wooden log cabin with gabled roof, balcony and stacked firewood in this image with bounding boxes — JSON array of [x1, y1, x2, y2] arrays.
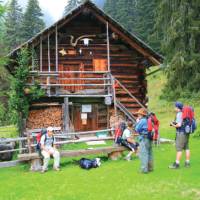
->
[[7, 1, 162, 132]]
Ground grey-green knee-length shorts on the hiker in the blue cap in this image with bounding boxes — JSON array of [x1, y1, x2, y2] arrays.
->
[[176, 132, 190, 151]]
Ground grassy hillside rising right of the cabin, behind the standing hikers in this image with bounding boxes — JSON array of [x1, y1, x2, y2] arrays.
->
[[147, 66, 200, 138]]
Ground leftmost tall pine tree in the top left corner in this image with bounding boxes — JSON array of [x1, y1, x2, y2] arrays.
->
[[4, 0, 22, 50]]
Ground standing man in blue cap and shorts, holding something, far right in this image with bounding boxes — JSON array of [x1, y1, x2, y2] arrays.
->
[[169, 102, 190, 169]]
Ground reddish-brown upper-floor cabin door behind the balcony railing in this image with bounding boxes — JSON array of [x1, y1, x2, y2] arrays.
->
[[59, 63, 84, 93]]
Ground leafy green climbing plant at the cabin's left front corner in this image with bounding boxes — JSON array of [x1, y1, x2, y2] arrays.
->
[[9, 49, 44, 132]]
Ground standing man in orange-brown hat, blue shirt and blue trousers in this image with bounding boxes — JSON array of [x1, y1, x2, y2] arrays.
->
[[135, 108, 153, 173]]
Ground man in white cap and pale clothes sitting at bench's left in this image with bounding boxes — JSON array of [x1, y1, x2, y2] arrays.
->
[[40, 127, 60, 173]]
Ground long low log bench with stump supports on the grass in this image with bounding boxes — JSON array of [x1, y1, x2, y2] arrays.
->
[[18, 146, 127, 171]]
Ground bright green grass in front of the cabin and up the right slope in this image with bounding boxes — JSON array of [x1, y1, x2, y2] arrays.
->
[[0, 68, 200, 200]]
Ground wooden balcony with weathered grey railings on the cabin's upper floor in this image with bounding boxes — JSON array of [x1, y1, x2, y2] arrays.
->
[[27, 71, 112, 97]]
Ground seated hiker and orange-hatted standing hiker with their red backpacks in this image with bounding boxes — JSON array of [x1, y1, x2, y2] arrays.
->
[[115, 108, 159, 173]]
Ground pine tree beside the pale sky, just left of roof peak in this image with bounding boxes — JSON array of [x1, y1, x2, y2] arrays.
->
[[21, 0, 45, 41]]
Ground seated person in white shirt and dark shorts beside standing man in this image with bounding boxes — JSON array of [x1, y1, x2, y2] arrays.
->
[[122, 121, 139, 161]]
